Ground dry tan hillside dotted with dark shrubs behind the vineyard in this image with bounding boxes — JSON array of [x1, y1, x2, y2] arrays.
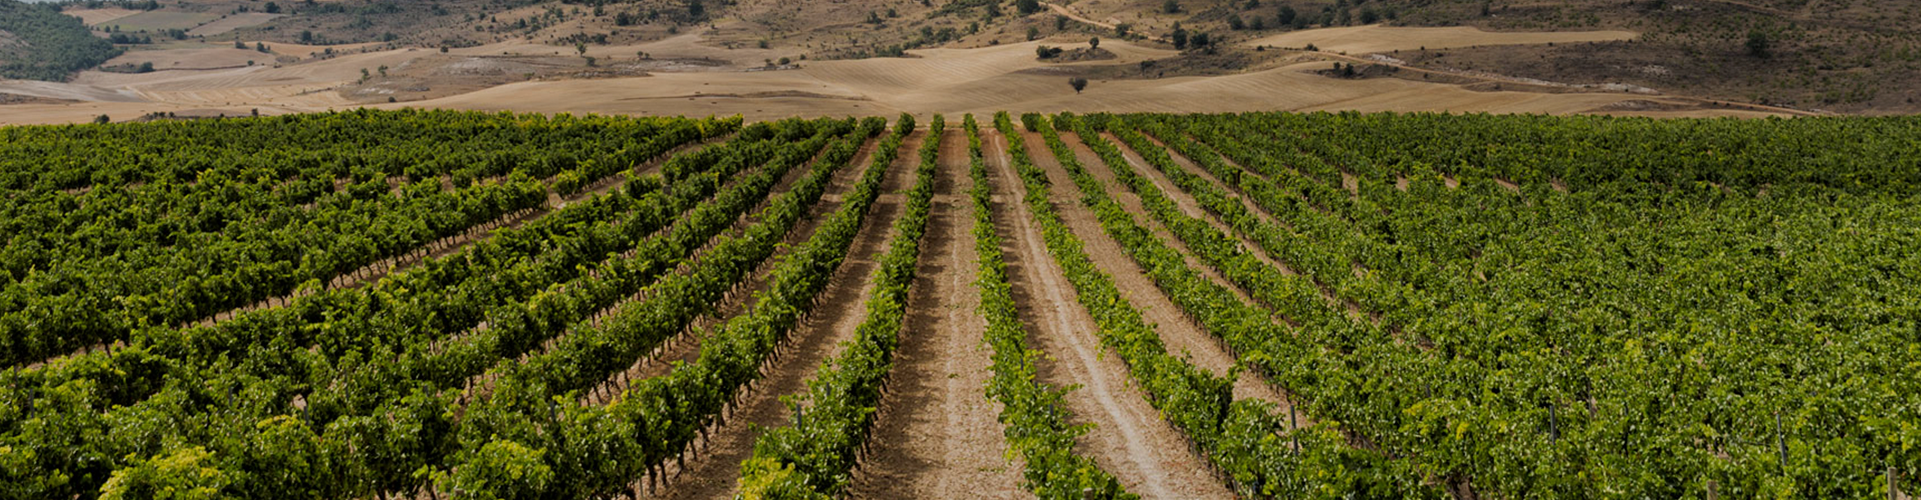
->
[[0, 0, 1921, 123]]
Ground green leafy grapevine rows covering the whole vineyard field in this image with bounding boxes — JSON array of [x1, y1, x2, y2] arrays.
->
[[0, 110, 1921, 498]]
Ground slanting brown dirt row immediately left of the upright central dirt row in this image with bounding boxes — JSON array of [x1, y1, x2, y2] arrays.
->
[[659, 131, 926, 498]]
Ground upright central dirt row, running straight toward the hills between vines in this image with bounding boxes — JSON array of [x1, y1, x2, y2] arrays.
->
[[849, 123, 1033, 498]]
